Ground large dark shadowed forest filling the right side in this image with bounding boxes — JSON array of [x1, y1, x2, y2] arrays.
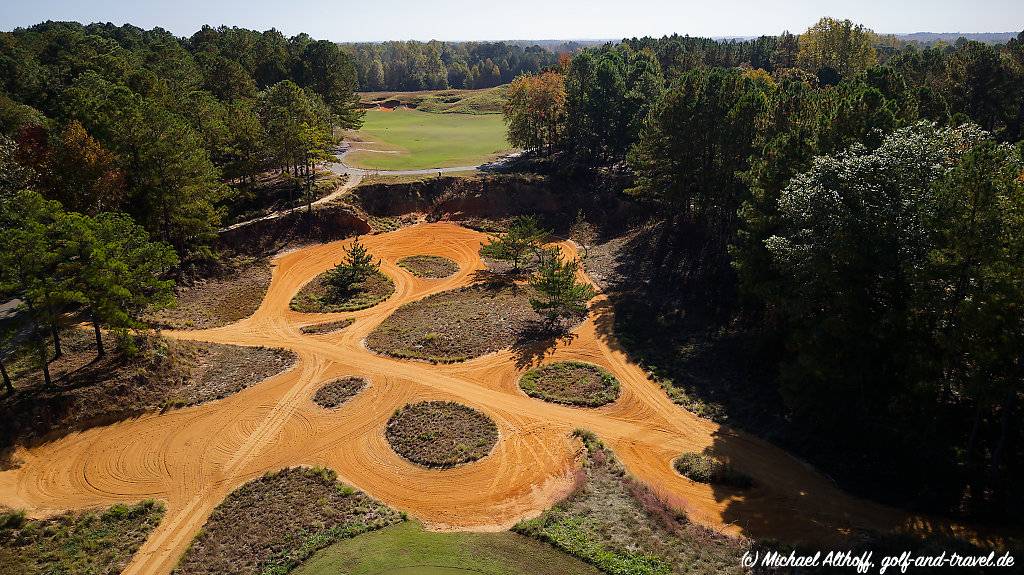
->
[[505, 18, 1024, 520]]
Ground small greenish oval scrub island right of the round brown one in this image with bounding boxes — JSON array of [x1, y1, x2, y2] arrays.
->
[[519, 361, 618, 407]]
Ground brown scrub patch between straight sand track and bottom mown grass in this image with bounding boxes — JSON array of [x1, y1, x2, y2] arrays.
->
[[174, 468, 404, 575]]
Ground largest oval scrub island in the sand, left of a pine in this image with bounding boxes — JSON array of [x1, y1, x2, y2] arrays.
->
[[367, 281, 544, 363]]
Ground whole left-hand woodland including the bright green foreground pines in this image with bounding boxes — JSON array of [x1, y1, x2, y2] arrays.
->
[[0, 21, 361, 392]]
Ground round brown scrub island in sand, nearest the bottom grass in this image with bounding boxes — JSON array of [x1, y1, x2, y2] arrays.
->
[[385, 401, 498, 468]]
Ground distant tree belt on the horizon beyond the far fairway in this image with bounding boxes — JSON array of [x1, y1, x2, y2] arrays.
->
[[345, 40, 574, 91]]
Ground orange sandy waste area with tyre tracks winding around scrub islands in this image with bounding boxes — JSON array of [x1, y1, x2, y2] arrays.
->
[[0, 223, 978, 575]]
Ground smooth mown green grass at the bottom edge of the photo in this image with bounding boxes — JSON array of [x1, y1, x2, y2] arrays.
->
[[295, 521, 600, 575]]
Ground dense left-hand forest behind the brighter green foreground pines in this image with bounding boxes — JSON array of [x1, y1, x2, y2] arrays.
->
[[0, 21, 361, 267]]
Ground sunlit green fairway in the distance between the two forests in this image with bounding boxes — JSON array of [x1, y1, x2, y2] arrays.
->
[[345, 108, 510, 170]]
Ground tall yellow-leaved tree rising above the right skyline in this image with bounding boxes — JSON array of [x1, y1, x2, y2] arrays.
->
[[797, 17, 878, 78]]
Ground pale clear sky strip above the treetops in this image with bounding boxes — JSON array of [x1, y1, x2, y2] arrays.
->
[[0, 0, 1024, 42]]
